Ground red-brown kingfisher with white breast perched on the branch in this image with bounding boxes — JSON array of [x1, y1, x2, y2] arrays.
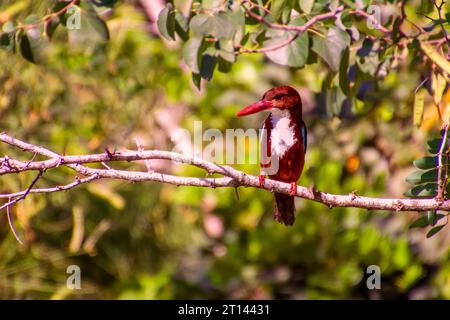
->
[[236, 86, 307, 225]]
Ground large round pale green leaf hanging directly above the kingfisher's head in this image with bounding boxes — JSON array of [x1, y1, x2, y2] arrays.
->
[[264, 17, 309, 68]]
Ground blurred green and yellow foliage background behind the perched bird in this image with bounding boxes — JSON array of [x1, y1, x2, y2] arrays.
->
[[0, 0, 450, 299]]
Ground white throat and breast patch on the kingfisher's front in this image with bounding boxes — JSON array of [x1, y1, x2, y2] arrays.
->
[[270, 109, 297, 158]]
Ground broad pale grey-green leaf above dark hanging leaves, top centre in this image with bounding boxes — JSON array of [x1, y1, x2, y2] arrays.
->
[[190, 12, 236, 39]]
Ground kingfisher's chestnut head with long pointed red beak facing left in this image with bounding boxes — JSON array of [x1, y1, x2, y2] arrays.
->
[[236, 86, 302, 117]]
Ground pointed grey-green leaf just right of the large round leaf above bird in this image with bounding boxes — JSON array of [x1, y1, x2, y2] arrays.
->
[[312, 27, 350, 72]]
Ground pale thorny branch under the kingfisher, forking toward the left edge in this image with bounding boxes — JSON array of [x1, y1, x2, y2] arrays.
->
[[0, 133, 450, 211]]
